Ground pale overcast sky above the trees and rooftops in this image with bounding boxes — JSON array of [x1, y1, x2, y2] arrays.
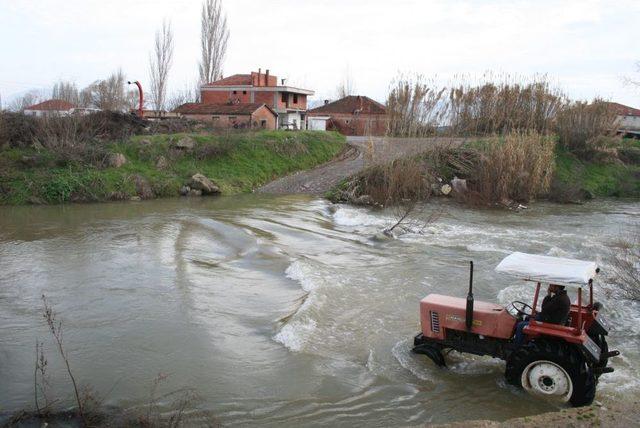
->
[[0, 0, 640, 107]]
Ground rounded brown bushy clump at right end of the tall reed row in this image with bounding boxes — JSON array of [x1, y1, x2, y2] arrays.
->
[[556, 99, 617, 159]]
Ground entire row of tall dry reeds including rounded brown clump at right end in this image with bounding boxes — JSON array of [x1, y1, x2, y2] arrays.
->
[[387, 74, 617, 158]]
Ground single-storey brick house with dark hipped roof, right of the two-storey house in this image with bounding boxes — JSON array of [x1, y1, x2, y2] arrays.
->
[[308, 95, 388, 136]]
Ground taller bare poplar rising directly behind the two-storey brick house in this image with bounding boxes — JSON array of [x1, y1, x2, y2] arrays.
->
[[198, 0, 229, 84]]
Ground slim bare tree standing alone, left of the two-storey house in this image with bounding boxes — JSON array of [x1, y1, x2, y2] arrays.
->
[[149, 21, 173, 112]]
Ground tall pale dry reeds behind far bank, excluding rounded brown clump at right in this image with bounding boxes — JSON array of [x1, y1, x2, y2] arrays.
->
[[387, 75, 566, 137]]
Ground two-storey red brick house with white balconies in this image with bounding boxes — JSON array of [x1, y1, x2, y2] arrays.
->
[[200, 70, 314, 129]]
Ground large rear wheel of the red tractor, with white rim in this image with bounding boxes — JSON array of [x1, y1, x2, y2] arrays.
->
[[505, 341, 596, 407]]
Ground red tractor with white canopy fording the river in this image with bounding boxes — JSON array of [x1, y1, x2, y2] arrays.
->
[[413, 253, 619, 407]]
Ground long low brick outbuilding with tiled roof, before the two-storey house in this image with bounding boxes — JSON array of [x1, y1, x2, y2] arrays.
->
[[175, 103, 278, 129]]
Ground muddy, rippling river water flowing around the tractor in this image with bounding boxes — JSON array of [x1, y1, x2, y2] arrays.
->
[[0, 195, 640, 426]]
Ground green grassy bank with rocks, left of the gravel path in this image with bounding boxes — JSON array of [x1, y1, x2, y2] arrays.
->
[[0, 131, 345, 205]]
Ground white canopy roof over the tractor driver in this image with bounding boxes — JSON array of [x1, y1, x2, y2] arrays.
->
[[496, 253, 598, 287]]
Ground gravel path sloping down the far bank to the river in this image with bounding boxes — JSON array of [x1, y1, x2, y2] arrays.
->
[[258, 137, 463, 194]]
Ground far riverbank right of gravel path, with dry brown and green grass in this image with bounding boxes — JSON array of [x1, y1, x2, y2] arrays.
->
[[325, 134, 640, 207]]
